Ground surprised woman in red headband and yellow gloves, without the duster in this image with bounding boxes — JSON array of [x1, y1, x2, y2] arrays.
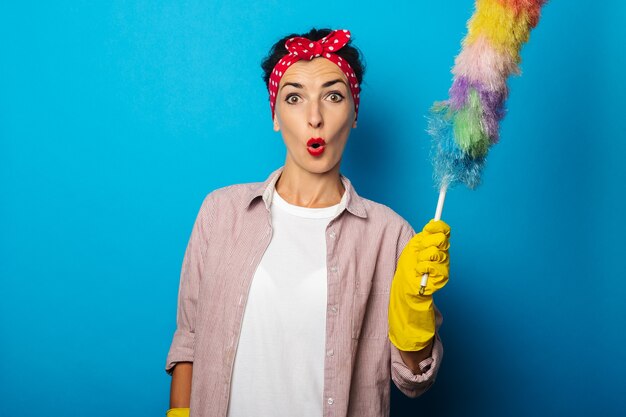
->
[[165, 29, 450, 417]]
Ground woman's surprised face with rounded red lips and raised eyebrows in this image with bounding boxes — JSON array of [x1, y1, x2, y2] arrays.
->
[[274, 57, 356, 174]]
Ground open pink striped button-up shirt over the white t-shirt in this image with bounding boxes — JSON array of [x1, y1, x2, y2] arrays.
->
[[165, 167, 443, 417]]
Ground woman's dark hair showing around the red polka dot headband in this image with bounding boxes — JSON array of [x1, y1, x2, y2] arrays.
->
[[261, 28, 365, 87]]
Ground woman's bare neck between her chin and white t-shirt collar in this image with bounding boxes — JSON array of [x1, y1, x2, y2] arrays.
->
[[275, 159, 345, 208]]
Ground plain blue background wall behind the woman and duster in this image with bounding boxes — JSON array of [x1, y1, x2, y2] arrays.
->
[[0, 0, 626, 417]]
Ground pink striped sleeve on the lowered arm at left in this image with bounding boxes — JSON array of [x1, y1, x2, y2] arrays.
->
[[165, 194, 213, 375]]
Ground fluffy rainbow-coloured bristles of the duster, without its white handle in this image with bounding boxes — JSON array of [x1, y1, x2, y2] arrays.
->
[[428, 0, 547, 190]]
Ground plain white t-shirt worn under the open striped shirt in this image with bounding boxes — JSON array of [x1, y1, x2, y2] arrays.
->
[[228, 189, 347, 417]]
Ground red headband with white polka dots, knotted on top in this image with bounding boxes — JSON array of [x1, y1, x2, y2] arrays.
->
[[268, 29, 361, 119]]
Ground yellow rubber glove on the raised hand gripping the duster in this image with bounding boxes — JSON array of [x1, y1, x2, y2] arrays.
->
[[389, 220, 450, 351]]
